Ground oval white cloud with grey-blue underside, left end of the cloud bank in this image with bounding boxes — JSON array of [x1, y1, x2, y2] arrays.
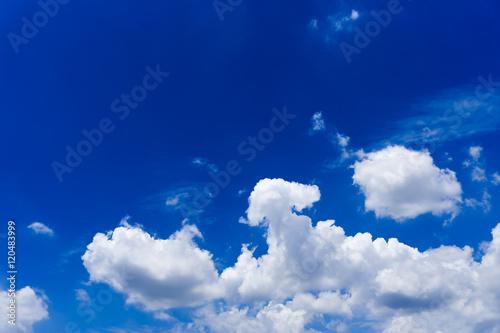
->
[[82, 223, 221, 311]]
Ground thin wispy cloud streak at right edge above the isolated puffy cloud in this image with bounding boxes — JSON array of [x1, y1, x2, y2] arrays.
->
[[379, 75, 500, 148]]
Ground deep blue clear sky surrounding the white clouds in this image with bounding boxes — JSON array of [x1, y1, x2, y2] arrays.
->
[[0, 0, 500, 332]]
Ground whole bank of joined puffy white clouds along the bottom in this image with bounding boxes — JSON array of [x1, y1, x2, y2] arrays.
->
[[83, 178, 500, 333]]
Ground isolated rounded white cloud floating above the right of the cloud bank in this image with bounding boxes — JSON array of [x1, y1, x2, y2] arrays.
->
[[353, 146, 462, 221]]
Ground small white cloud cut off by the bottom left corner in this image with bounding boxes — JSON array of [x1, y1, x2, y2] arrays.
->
[[0, 287, 49, 333]]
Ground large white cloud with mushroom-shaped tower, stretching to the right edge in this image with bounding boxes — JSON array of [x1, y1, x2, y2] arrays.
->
[[221, 179, 500, 332]]
